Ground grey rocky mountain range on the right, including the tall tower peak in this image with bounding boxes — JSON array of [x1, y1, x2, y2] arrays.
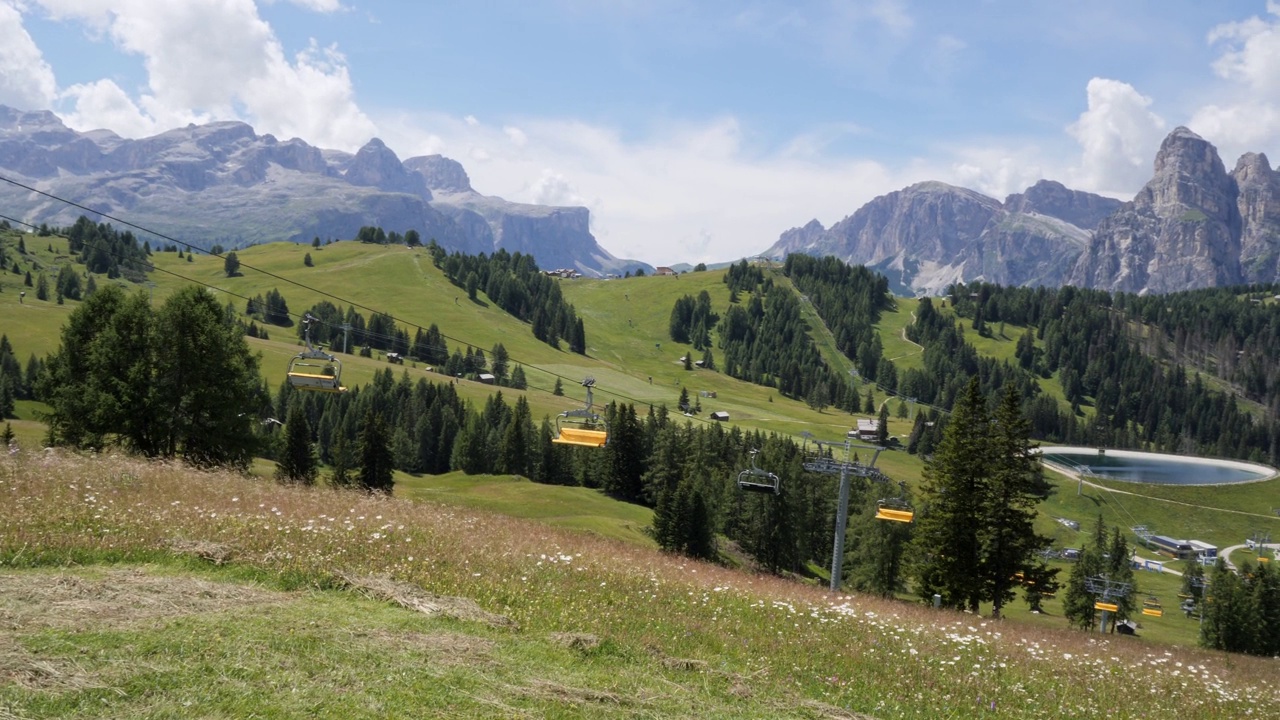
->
[[764, 127, 1280, 295]]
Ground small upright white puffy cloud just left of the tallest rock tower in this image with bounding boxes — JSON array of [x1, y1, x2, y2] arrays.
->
[[1068, 77, 1165, 195]]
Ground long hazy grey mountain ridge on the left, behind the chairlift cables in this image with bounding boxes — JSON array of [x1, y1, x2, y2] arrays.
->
[[0, 105, 652, 275]]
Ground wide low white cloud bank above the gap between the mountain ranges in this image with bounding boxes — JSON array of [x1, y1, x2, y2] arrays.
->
[[376, 114, 916, 265]]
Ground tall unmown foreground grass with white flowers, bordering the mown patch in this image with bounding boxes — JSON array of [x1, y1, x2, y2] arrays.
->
[[0, 451, 1277, 719]]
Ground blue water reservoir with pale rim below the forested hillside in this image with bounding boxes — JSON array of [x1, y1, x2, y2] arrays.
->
[[1041, 447, 1276, 486]]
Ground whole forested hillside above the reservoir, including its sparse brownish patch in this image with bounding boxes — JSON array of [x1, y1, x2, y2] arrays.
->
[[947, 284, 1280, 465]]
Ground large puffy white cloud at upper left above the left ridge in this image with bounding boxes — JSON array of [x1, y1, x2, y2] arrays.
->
[[38, 0, 374, 150]]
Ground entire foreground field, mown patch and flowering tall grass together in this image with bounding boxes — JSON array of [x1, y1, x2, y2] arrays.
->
[[0, 451, 1280, 720]]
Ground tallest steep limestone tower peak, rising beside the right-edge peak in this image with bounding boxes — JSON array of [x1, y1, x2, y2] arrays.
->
[[1068, 127, 1243, 293]]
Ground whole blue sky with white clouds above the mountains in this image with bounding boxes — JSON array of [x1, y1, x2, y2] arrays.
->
[[0, 0, 1280, 264]]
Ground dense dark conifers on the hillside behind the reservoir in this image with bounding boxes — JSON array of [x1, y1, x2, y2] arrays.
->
[[947, 283, 1280, 464]]
